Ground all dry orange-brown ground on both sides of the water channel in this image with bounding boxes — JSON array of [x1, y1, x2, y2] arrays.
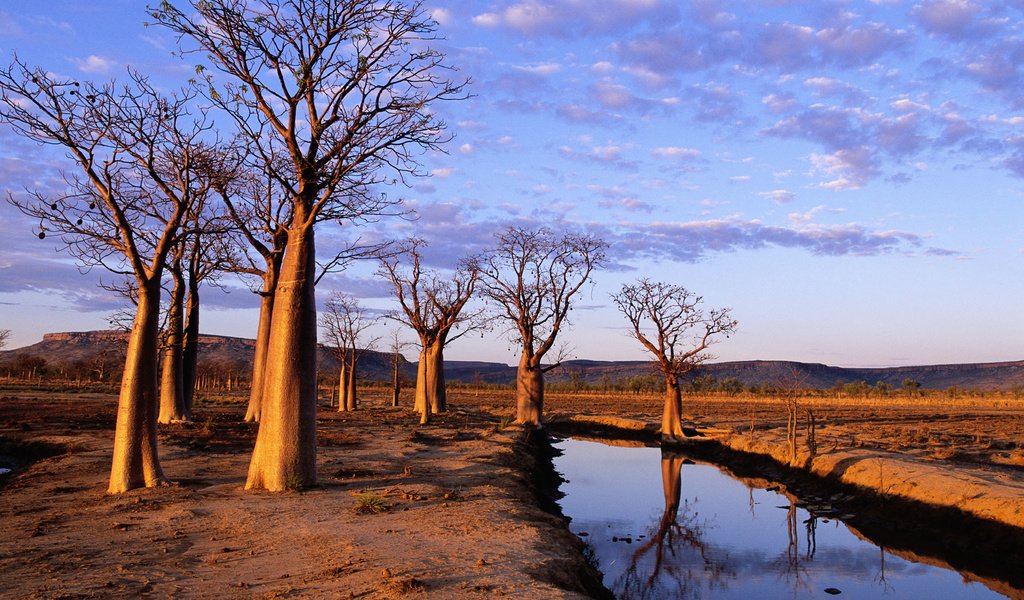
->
[[0, 389, 1024, 598]]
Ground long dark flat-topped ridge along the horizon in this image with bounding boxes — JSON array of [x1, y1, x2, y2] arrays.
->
[[0, 331, 1024, 390]]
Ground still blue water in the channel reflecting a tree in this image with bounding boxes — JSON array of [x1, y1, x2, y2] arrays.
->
[[555, 439, 1006, 600]]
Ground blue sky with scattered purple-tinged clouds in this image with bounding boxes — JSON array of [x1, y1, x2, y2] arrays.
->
[[0, 0, 1024, 367]]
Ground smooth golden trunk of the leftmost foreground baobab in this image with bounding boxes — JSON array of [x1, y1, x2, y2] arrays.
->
[[106, 272, 165, 494]]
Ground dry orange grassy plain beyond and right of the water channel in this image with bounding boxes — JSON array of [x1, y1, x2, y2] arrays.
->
[[489, 391, 1024, 470]]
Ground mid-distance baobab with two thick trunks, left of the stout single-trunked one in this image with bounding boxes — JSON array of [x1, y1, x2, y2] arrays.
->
[[378, 238, 480, 423]]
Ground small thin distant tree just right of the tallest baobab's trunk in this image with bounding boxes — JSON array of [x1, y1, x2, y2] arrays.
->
[[321, 292, 379, 411]]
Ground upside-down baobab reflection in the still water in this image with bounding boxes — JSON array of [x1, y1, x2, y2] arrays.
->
[[612, 448, 735, 599]]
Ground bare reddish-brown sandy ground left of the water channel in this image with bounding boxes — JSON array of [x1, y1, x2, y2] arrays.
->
[[0, 390, 598, 598]]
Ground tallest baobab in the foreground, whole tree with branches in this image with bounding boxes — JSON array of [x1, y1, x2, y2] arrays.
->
[[151, 0, 464, 490]]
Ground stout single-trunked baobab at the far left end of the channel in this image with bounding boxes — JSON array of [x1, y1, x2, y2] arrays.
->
[[474, 227, 608, 427]]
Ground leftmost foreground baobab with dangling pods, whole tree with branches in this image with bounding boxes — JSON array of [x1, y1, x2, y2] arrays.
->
[[0, 57, 208, 494]]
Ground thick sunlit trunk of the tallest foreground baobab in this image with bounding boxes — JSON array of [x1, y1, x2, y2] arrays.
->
[[246, 225, 316, 491]]
